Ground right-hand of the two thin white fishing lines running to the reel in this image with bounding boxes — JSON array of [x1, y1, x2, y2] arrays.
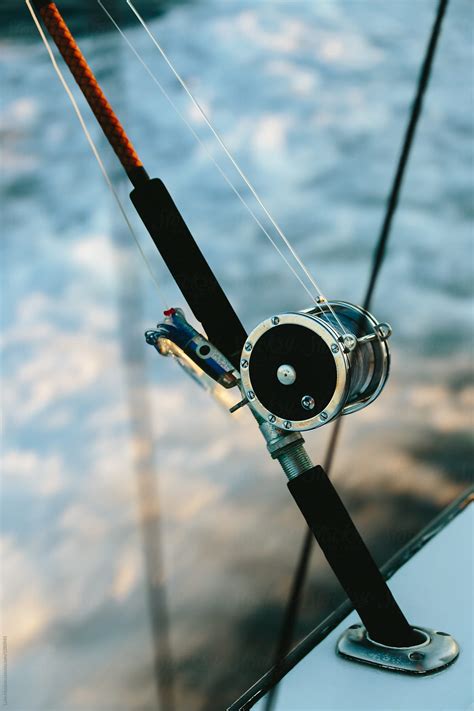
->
[[125, 0, 347, 335]]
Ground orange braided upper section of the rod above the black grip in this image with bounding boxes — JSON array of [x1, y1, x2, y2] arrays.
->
[[39, 2, 143, 173]]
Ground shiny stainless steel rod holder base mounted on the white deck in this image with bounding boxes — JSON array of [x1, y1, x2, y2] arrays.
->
[[337, 624, 459, 675]]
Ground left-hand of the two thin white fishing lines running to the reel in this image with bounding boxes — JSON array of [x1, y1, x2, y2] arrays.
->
[[97, 0, 317, 303]]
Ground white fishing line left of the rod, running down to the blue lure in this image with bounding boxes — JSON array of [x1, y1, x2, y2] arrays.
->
[[25, 0, 169, 309]]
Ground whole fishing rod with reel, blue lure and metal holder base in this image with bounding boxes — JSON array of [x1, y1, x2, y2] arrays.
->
[[26, 0, 459, 674]]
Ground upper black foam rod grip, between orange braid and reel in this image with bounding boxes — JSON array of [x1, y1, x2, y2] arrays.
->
[[130, 178, 247, 369]]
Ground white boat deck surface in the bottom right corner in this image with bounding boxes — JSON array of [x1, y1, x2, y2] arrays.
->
[[253, 505, 474, 711]]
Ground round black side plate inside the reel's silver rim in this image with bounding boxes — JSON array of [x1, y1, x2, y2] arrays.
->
[[249, 324, 337, 421]]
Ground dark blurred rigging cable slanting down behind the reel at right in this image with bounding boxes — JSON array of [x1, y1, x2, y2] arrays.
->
[[265, 0, 448, 711]]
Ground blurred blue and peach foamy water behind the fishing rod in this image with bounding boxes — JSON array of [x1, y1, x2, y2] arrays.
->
[[0, 0, 474, 711]]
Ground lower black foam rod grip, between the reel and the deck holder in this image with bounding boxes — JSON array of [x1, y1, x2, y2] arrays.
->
[[288, 466, 419, 647]]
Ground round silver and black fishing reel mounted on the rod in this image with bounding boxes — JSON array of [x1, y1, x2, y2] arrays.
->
[[240, 301, 391, 431]]
